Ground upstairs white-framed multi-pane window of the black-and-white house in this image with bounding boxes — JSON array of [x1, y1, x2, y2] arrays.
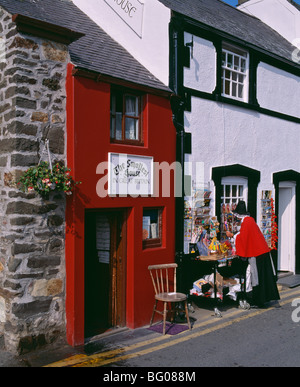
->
[[222, 44, 249, 102]]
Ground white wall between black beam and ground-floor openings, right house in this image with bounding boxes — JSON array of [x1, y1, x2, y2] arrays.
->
[[185, 98, 300, 215]]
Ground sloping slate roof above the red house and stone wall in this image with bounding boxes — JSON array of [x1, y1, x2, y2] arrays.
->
[[0, 0, 171, 92]]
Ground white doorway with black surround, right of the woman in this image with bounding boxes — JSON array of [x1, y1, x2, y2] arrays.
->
[[278, 182, 296, 274]]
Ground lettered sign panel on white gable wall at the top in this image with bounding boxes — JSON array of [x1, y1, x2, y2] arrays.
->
[[104, 0, 144, 38]]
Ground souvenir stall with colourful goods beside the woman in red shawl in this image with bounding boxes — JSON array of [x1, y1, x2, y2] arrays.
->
[[186, 196, 250, 317]]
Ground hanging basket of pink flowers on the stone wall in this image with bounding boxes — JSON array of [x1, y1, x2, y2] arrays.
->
[[18, 161, 80, 197]]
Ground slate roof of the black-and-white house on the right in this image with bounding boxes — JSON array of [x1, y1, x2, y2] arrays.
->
[[159, 0, 296, 65]]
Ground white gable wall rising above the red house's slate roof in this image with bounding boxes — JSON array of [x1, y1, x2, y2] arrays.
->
[[72, 0, 171, 85]]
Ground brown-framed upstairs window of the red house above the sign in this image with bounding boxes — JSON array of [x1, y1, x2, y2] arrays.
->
[[110, 89, 142, 145]]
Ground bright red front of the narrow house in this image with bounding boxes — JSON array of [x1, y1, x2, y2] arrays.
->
[[66, 65, 176, 345]]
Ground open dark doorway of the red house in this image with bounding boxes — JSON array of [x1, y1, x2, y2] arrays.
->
[[84, 210, 127, 338]]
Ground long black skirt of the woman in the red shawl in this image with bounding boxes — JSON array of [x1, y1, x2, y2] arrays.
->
[[252, 253, 280, 306]]
